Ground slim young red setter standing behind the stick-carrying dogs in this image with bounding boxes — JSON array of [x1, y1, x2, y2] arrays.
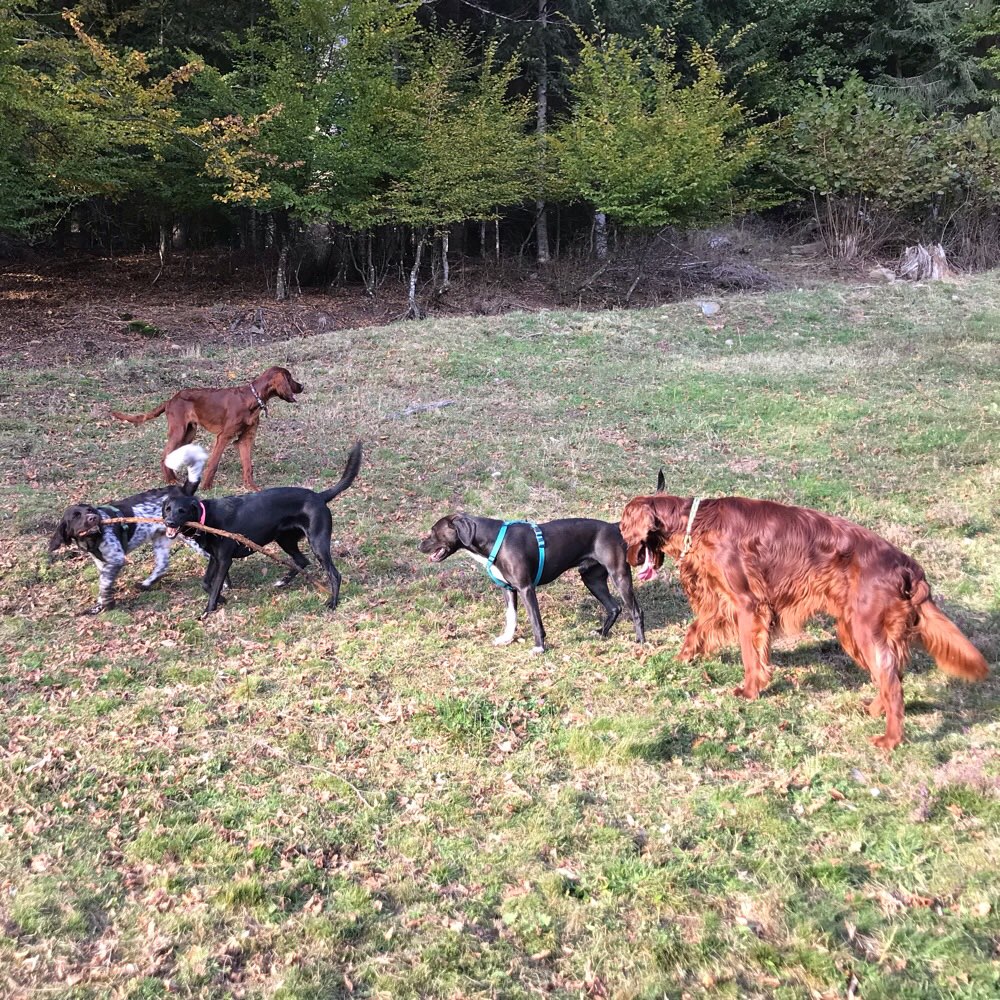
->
[[111, 366, 303, 490]]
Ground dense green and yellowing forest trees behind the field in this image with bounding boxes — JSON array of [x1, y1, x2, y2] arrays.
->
[[0, 0, 1000, 312]]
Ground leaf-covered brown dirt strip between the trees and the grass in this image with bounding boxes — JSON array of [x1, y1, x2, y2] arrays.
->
[[0, 238, 844, 365]]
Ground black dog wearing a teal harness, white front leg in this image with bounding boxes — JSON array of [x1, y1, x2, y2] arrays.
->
[[420, 514, 645, 653]]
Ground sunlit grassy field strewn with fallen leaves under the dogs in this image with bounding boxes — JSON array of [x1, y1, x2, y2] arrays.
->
[[0, 275, 1000, 1000]]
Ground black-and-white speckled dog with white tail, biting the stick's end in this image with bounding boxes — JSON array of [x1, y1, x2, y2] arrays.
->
[[49, 444, 208, 614]]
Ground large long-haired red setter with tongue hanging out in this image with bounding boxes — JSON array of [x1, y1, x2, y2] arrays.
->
[[621, 494, 987, 750]]
